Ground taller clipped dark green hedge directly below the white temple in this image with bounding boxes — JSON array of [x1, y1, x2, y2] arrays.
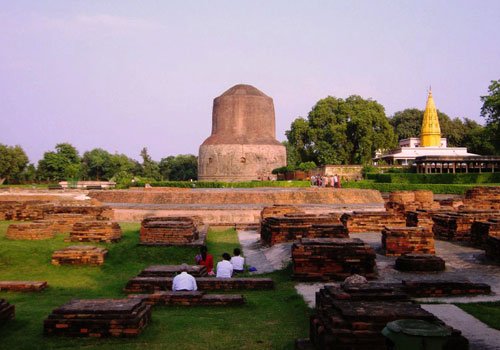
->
[[366, 173, 500, 184]]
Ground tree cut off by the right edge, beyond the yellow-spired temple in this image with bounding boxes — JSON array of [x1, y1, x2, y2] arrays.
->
[[481, 79, 500, 154]]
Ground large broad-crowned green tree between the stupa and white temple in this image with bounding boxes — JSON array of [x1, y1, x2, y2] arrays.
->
[[286, 95, 395, 165]]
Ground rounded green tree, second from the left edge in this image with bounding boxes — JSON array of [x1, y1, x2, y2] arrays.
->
[[37, 143, 80, 181]]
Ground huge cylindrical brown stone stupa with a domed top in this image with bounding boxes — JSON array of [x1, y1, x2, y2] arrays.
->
[[198, 84, 286, 181]]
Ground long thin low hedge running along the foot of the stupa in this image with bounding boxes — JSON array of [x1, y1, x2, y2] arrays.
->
[[131, 181, 311, 188]]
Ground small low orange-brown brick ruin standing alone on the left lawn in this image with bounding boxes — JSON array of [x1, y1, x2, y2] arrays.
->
[[52, 245, 108, 266]]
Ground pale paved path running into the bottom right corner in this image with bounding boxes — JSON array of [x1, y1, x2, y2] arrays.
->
[[422, 304, 500, 350]]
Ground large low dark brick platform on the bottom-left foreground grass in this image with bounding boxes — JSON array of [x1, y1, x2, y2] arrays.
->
[[43, 298, 151, 337]]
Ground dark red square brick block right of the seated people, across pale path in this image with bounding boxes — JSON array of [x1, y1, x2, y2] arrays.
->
[[292, 238, 377, 281]]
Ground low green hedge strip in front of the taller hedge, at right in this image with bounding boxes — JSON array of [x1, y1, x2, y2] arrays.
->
[[342, 180, 498, 194]]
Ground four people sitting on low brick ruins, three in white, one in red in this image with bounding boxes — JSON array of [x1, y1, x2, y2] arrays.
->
[[172, 246, 245, 292]]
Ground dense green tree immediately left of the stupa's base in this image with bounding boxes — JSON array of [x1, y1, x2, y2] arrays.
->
[[159, 154, 198, 181]]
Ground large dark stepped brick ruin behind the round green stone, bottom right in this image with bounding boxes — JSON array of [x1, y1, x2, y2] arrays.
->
[[295, 283, 468, 350]]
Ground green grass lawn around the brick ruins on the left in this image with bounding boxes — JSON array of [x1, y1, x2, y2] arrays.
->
[[0, 221, 312, 350]]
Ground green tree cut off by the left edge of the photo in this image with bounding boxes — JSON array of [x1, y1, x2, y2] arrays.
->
[[0, 144, 29, 185]]
